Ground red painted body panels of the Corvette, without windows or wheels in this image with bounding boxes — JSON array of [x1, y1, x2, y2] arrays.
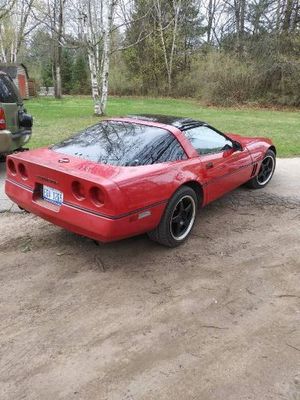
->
[[5, 114, 272, 242]]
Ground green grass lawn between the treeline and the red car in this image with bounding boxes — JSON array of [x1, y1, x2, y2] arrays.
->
[[26, 96, 300, 157]]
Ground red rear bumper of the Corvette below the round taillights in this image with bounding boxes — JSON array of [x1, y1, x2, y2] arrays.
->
[[5, 179, 166, 242]]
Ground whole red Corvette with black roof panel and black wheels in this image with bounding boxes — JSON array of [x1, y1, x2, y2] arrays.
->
[[5, 115, 276, 247]]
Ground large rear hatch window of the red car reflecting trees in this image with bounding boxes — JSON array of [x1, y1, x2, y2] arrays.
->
[[52, 121, 186, 166]]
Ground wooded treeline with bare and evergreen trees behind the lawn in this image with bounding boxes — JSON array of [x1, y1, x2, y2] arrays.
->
[[0, 0, 300, 114]]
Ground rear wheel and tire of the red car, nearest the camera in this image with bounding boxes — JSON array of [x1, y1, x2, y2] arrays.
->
[[148, 186, 198, 247]]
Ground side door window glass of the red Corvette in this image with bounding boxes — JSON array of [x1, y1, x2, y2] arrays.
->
[[183, 125, 232, 154]]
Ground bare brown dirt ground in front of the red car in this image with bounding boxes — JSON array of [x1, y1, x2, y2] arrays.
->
[[0, 161, 300, 400]]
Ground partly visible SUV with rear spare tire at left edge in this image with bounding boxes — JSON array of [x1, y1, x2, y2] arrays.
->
[[0, 71, 32, 157]]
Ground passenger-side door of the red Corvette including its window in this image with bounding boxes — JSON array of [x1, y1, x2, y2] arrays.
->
[[184, 125, 253, 202]]
